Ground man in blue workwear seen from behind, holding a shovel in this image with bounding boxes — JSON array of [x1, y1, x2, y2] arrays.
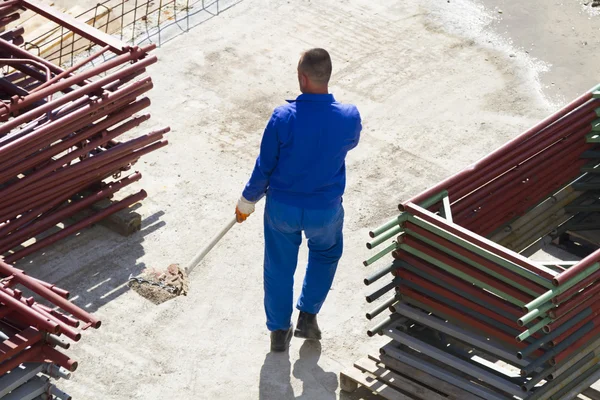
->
[[236, 49, 362, 351]]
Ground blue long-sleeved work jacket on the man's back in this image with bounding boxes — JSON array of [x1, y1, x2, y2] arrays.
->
[[242, 94, 362, 209]]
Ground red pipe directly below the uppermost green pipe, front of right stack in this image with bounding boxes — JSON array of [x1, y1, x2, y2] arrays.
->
[[404, 221, 547, 295]]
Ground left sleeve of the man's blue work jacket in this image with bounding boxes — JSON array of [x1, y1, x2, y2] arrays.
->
[[242, 111, 279, 201]]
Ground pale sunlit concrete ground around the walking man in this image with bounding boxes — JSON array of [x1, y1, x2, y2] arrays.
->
[[16, 0, 598, 400]]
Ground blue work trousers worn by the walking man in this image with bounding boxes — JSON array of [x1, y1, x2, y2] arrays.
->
[[264, 197, 344, 331]]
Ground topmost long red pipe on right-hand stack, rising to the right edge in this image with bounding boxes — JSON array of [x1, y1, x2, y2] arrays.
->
[[400, 87, 597, 206]]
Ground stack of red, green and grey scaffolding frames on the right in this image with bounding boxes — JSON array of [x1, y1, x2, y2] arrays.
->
[[352, 85, 600, 400]]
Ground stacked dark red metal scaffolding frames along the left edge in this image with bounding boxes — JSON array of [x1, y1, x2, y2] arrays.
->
[[0, 0, 169, 399]]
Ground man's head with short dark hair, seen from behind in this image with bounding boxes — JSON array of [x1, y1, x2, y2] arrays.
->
[[298, 49, 332, 94]]
